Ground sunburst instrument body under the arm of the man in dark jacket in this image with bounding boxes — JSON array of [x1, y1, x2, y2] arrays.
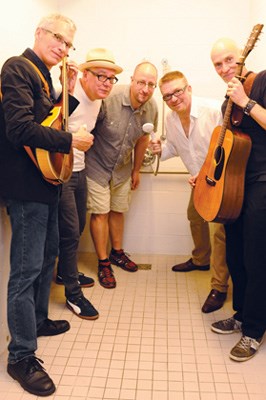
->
[[35, 106, 73, 183]]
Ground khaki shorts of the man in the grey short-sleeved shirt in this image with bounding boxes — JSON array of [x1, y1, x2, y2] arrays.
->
[[87, 177, 131, 214]]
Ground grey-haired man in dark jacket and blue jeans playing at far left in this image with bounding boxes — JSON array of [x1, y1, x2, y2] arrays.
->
[[0, 14, 90, 396]]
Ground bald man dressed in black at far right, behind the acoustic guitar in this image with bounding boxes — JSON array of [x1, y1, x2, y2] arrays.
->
[[211, 38, 266, 361]]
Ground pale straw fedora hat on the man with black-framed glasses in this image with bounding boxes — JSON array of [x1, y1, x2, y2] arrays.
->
[[79, 48, 123, 74]]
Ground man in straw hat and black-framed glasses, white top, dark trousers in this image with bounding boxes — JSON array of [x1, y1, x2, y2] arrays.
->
[[56, 48, 123, 320]]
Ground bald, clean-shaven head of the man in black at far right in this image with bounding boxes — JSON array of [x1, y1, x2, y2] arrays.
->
[[211, 38, 244, 83]]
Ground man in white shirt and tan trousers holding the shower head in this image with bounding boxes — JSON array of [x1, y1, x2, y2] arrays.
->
[[152, 71, 229, 313]]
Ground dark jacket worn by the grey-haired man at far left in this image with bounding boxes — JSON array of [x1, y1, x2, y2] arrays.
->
[[0, 49, 78, 204]]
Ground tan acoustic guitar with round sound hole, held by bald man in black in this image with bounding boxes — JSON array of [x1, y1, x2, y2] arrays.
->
[[194, 24, 263, 224]]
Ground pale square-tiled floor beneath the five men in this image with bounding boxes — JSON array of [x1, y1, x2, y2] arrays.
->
[[0, 254, 266, 400]]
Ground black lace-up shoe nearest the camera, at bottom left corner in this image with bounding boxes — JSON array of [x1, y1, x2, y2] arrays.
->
[[7, 356, 55, 396]]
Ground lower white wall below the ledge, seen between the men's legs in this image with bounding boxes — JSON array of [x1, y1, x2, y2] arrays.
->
[[80, 174, 192, 254]]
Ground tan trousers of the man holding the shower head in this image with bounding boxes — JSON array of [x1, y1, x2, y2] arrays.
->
[[187, 190, 229, 292]]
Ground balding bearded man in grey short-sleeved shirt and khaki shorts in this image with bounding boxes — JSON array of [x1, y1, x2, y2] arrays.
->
[[86, 62, 158, 289]]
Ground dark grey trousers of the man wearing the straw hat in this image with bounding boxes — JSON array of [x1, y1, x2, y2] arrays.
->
[[57, 169, 87, 298]]
